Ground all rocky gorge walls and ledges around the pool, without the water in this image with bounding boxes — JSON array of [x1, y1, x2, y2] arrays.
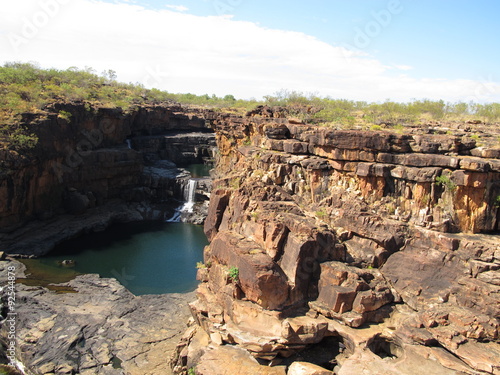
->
[[0, 103, 500, 375]]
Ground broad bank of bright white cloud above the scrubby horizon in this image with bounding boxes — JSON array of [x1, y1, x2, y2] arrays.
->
[[0, 0, 500, 101]]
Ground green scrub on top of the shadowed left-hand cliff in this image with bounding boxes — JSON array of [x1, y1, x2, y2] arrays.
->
[[0, 63, 253, 150]]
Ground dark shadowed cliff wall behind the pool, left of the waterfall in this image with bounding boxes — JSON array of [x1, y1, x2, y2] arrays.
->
[[0, 103, 215, 255]]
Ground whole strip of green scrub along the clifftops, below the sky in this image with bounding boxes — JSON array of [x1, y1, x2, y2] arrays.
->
[[0, 63, 500, 150]]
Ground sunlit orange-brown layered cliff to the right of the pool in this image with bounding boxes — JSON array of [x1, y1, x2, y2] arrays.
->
[[172, 108, 500, 375]]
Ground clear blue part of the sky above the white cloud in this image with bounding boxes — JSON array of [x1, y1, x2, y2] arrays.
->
[[130, 0, 500, 79]]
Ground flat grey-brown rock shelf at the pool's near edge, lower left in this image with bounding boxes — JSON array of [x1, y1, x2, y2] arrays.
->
[[0, 261, 194, 375]]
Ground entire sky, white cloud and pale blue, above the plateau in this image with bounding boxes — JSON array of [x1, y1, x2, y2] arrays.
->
[[0, 0, 500, 103]]
